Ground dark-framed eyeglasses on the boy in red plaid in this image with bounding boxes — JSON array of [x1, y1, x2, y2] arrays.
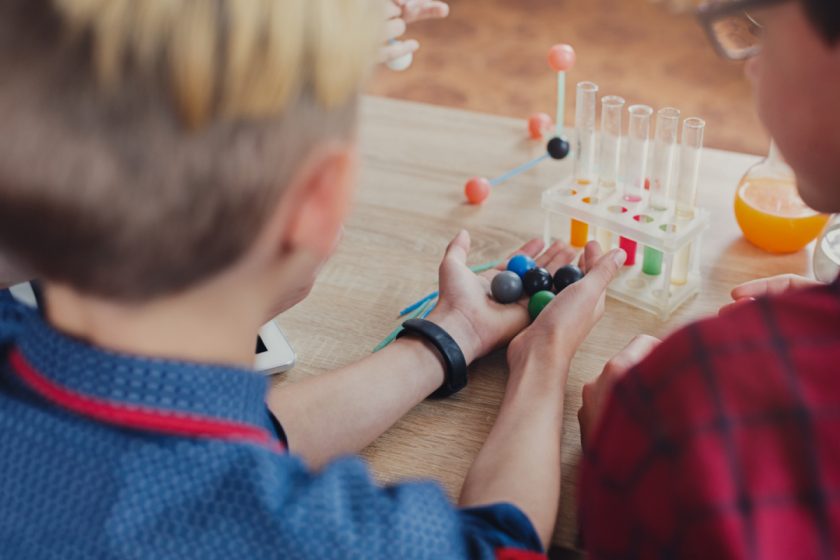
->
[[697, 0, 790, 60]]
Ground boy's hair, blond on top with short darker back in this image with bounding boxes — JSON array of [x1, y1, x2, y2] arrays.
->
[[0, 0, 384, 301]]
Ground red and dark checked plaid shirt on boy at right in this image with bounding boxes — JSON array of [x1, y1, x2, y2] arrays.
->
[[579, 283, 840, 560]]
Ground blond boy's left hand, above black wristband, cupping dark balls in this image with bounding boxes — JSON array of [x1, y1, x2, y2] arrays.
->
[[429, 231, 575, 363]]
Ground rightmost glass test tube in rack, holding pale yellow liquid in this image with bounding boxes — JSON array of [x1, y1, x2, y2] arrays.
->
[[671, 117, 706, 286]]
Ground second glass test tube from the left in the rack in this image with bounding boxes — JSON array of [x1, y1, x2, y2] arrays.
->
[[595, 95, 626, 251]]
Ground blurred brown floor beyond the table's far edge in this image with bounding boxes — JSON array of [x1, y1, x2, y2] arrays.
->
[[369, 0, 769, 154]]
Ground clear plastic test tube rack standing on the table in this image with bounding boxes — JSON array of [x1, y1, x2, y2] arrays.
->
[[542, 184, 709, 320]]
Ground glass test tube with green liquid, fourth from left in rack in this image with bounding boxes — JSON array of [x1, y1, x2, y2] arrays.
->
[[642, 107, 680, 276]]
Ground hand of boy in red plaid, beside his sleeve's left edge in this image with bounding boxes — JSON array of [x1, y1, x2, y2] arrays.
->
[[578, 334, 661, 449]]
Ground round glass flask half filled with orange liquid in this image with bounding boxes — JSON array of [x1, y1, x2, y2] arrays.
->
[[735, 143, 829, 253]]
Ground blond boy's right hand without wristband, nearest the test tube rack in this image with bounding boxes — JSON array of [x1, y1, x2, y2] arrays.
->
[[507, 241, 627, 380]]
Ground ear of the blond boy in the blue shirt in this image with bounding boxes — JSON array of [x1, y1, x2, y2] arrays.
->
[[281, 144, 358, 258]]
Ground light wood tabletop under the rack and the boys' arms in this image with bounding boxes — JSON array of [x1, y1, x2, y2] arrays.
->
[[270, 98, 809, 546]]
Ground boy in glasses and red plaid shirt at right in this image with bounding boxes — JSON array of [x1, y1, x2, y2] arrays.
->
[[579, 0, 840, 559]]
